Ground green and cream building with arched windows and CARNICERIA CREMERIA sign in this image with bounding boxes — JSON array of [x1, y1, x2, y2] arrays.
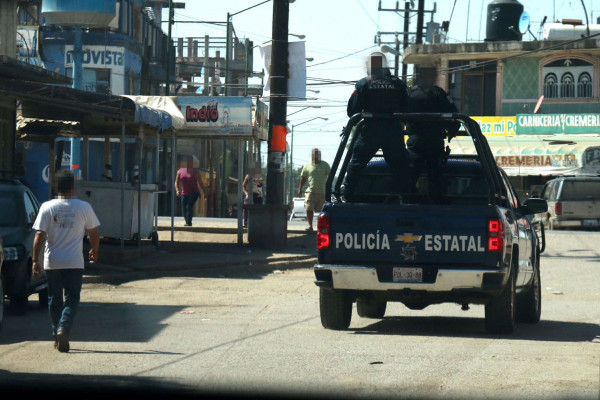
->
[[403, 24, 600, 193]]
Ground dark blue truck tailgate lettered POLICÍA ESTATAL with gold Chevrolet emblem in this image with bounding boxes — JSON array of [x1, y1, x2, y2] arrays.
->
[[319, 203, 498, 268]]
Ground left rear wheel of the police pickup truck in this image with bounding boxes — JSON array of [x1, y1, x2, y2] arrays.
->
[[319, 288, 352, 331]]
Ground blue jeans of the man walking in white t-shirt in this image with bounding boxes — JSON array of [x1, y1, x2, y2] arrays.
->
[[46, 268, 83, 336]]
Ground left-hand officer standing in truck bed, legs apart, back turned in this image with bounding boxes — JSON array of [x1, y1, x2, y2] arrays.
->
[[341, 52, 411, 201]]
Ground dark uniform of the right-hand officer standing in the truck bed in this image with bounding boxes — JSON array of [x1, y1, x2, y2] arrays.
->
[[407, 84, 460, 202]]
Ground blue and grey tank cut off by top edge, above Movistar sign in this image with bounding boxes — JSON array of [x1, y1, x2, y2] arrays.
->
[[42, 0, 117, 27]]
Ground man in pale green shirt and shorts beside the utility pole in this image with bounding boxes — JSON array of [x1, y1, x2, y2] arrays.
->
[[298, 148, 331, 232]]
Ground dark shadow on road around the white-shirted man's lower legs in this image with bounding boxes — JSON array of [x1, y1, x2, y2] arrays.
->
[[0, 302, 187, 346]]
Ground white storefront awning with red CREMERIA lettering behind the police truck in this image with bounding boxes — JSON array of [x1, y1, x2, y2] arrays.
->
[[450, 134, 600, 176]]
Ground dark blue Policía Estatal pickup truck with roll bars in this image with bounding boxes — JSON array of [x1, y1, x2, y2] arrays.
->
[[314, 113, 547, 333]]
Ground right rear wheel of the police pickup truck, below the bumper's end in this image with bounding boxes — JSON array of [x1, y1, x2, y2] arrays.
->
[[485, 262, 516, 333]]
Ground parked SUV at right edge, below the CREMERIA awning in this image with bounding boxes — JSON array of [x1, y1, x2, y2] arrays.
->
[[539, 176, 600, 230]]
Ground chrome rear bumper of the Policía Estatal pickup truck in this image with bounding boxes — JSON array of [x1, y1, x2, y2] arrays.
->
[[314, 264, 508, 292]]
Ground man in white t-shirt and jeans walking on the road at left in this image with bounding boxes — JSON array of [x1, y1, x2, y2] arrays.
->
[[32, 170, 100, 353]]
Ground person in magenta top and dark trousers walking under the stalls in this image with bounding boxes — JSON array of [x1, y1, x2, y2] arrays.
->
[[175, 157, 206, 226]]
